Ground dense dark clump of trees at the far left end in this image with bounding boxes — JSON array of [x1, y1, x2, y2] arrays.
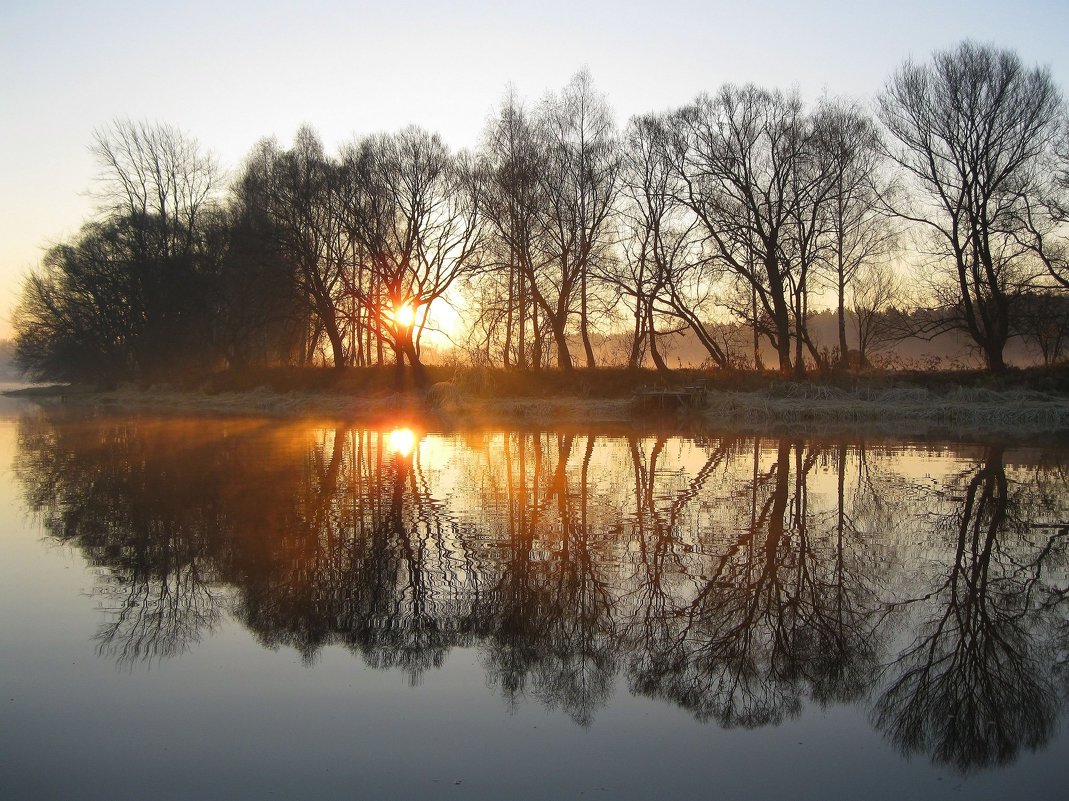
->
[[14, 121, 221, 383]]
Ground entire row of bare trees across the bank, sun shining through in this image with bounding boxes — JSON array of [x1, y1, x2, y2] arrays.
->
[[14, 42, 1069, 382]]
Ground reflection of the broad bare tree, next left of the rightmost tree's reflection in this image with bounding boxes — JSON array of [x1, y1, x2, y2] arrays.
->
[[632, 440, 879, 727]]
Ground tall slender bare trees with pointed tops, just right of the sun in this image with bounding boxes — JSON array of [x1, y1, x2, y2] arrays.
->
[[468, 72, 620, 370]]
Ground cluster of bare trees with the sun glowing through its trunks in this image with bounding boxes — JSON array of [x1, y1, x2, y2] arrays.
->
[[235, 127, 481, 367]]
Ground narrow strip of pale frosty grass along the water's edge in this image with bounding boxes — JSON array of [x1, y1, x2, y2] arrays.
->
[[3, 383, 1069, 444]]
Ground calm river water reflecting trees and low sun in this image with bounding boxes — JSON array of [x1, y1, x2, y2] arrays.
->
[[0, 404, 1069, 801]]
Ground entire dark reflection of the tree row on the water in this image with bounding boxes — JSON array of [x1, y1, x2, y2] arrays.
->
[[16, 415, 1069, 770]]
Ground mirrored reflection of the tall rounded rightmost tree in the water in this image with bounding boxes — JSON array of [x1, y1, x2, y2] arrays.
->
[[873, 447, 1069, 770]]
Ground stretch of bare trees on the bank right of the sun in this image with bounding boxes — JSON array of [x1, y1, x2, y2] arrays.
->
[[479, 43, 1069, 372]]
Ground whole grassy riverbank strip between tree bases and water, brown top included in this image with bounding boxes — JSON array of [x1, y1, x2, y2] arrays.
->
[[6, 369, 1069, 440]]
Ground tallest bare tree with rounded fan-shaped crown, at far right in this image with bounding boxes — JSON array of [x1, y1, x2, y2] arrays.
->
[[879, 42, 1060, 370]]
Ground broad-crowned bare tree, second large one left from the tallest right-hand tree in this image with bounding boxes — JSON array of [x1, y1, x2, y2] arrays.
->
[[672, 86, 827, 372]]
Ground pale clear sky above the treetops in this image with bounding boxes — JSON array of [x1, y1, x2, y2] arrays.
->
[[0, 0, 1069, 338]]
